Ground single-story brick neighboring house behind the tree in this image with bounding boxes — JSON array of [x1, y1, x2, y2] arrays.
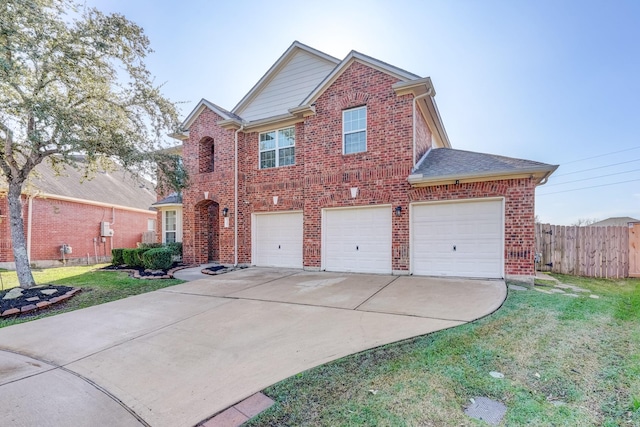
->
[[0, 160, 156, 268]]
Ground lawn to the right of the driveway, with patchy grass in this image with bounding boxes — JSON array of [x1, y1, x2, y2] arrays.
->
[[248, 276, 640, 426]]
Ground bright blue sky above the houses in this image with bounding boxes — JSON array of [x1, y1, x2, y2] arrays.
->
[[86, 0, 640, 225]]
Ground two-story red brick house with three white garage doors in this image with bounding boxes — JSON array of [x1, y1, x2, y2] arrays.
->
[[174, 42, 557, 281]]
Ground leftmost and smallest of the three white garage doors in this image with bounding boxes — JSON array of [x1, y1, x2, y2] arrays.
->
[[251, 212, 302, 268]]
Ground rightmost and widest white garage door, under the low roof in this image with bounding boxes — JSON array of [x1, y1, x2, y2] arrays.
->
[[411, 199, 504, 278]]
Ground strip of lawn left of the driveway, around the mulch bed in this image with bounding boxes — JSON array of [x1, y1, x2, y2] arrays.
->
[[0, 264, 183, 328]]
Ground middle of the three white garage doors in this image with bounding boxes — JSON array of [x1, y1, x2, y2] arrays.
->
[[322, 206, 391, 274]]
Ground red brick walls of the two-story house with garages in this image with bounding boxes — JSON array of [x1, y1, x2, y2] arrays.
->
[[183, 62, 535, 275]]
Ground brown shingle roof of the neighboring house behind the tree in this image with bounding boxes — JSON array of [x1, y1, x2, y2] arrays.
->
[[0, 158, 156, 210]]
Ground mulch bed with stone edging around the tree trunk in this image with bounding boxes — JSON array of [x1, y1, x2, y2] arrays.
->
[[0, 285, 80, 317]]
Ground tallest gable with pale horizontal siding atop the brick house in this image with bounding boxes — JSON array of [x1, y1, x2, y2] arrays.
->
[[232, 41, 340, 121]]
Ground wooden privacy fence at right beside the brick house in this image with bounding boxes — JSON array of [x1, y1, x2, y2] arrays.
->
[[535, 224, 640, 278]]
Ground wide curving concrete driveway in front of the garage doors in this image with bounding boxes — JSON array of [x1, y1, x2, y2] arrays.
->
[[0, 268, 507, 426]]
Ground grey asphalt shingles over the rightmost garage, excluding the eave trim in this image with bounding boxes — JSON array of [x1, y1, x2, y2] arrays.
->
[[411, 148, 556, 179]]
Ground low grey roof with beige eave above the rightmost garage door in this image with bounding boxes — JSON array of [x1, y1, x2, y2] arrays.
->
[[408, 148, 558, 186]]
